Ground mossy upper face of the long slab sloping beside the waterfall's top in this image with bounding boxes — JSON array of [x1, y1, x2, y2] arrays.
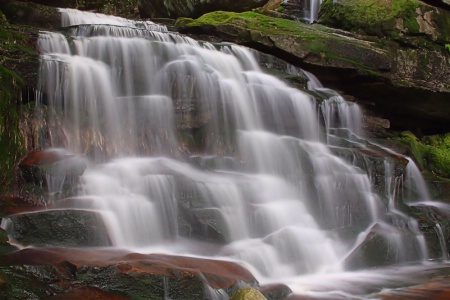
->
[[175, 11, 392, 77]]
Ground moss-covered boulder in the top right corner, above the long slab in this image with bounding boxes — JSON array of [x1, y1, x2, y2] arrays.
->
[[320, 0, 450, 43]]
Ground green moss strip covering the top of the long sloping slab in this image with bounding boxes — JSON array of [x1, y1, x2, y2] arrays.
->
[[175, 11, 390, 77]]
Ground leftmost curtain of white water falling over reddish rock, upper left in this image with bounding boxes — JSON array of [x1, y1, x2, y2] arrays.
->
[[40, 54, 121, 158]]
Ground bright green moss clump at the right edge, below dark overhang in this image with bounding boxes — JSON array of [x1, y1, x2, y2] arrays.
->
[[396, 131, 450, 178]]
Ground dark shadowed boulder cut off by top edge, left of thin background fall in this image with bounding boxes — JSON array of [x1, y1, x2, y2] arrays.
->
[[138, 0, 267, 19]]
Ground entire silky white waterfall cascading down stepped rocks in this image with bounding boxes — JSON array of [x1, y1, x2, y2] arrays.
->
[[3, 9, 447, 298]]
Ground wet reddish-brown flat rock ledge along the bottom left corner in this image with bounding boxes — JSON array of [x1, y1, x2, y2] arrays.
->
[[0, 248, 256, 299]]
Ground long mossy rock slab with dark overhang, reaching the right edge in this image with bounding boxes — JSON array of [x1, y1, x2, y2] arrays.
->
[[176, 12, 450, 132]]
